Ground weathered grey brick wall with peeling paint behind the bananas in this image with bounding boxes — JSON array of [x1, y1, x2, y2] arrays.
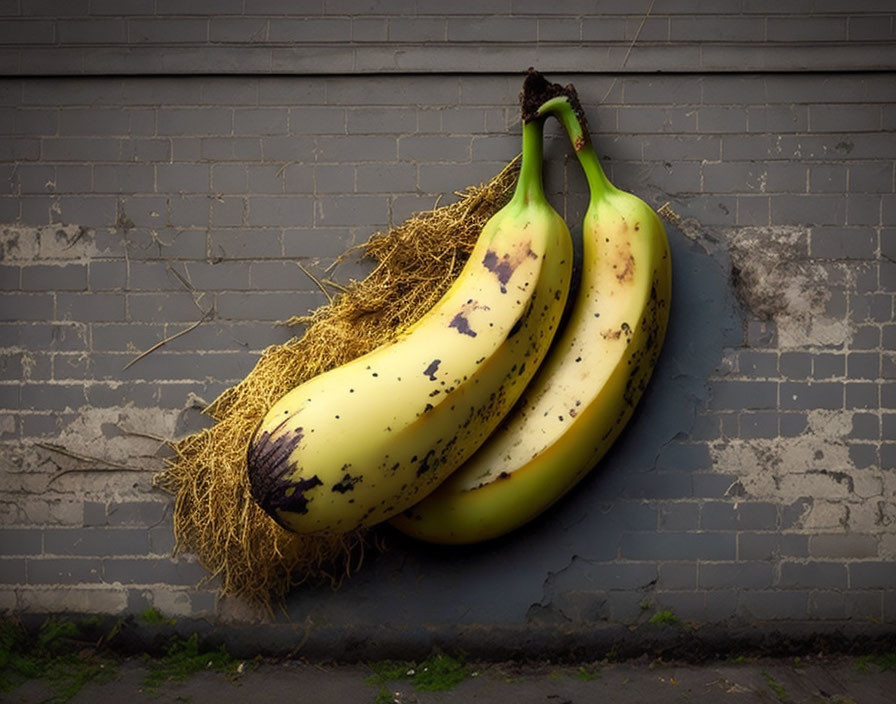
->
[[0, 0, 896, 648]]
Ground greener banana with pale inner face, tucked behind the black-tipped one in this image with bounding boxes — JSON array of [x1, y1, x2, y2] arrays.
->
[[391, 73, 671, 543]]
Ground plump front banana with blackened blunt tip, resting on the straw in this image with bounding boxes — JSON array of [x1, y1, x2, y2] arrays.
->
[[247, 93, 573, 533]]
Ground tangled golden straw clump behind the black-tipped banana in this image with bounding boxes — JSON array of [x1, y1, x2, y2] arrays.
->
[[155, 159, 518, 611]]
